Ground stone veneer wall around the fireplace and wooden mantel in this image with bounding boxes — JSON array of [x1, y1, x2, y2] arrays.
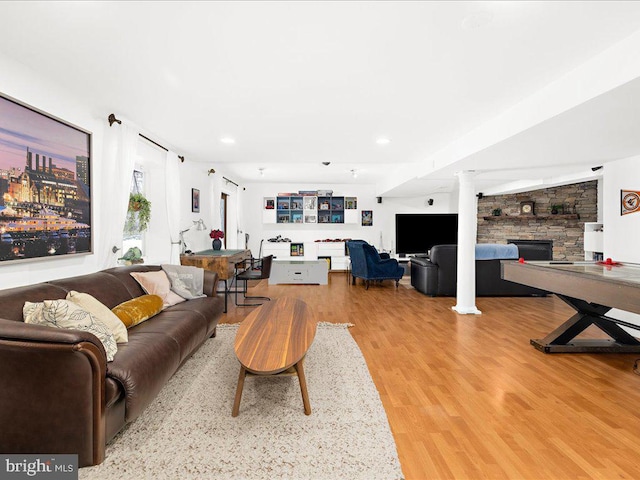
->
[[477, 180, 598, 261]]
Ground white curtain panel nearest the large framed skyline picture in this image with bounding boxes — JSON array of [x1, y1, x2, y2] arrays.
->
[[98, 122, 140, 269]]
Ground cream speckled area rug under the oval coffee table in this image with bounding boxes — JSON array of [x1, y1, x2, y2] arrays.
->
[[79, 323, 403, 480]]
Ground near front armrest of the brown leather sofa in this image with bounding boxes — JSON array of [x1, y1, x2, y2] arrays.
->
[[0, 319, 107, 466]]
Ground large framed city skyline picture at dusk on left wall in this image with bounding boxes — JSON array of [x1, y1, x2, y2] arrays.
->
[[0, 94, 93, 263]]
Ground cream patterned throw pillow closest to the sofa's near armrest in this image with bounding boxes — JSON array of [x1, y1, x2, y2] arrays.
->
[[22, 299, 118, 362]]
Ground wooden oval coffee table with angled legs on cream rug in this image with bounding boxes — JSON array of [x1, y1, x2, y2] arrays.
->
[[231, 297, 317, 417]]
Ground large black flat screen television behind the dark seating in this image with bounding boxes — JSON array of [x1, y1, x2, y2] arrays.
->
[[396, 213, 458, 255]]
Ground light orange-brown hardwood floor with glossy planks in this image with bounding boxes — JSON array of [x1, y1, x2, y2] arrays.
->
[[223, 273, 640, 480]]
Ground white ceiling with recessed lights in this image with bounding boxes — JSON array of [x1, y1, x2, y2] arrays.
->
[[0, 1, 640, 196]]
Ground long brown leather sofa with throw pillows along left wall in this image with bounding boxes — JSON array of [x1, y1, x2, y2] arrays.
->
[[0, 265, 224, 466]]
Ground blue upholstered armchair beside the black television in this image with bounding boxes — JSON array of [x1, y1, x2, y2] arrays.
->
[[347, 240, 404, 289]]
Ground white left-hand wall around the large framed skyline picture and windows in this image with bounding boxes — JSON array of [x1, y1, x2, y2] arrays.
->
[[0, 53, 222, 288]]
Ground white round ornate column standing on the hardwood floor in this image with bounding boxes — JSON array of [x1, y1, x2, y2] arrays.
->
[[453, 170, 482, 314]]
